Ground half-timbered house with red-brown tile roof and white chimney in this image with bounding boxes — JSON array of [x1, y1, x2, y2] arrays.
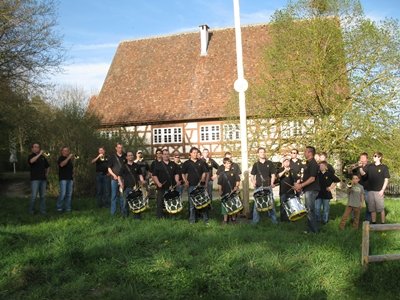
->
[[89, 24, 276, 156]]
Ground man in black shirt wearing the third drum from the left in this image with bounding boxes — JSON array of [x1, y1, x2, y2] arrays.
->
[[182, 147, 208, 224]]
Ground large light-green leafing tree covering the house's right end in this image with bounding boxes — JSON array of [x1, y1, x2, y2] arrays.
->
[[230, 0, 400, 172]]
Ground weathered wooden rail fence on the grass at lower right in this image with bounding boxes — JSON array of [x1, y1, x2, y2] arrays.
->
[[361, 221, 400, 265]]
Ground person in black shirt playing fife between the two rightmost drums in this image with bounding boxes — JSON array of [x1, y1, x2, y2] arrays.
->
[[278, 158, 296, 222]]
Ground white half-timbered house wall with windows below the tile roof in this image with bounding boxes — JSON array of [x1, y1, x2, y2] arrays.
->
[[100, 119, 312, 161]]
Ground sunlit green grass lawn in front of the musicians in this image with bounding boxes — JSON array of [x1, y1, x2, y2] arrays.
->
[[0, 198, 400, 299]]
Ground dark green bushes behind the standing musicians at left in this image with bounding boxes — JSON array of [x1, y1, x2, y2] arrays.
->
[[0, 87, 125, 195]]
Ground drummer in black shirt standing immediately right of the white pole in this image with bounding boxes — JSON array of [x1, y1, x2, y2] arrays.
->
[[250, 147, 278, 224]]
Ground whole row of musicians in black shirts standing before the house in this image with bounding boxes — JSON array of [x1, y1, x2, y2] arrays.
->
[[28, 143, 390, 233]]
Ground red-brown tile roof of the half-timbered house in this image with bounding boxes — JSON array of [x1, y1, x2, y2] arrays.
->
[[89, 24, 268, 126]]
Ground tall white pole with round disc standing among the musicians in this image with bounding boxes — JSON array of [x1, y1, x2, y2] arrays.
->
[[233, 0, 250, 217]]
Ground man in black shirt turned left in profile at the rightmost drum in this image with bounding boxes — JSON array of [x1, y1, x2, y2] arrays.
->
[[294, 146, 320, 233]]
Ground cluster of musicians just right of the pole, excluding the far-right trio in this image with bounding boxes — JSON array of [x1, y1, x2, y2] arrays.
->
[[250, 146, 340, 233]]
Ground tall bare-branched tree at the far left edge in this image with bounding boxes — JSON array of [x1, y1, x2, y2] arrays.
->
[[0, 0, 64, 169]]
